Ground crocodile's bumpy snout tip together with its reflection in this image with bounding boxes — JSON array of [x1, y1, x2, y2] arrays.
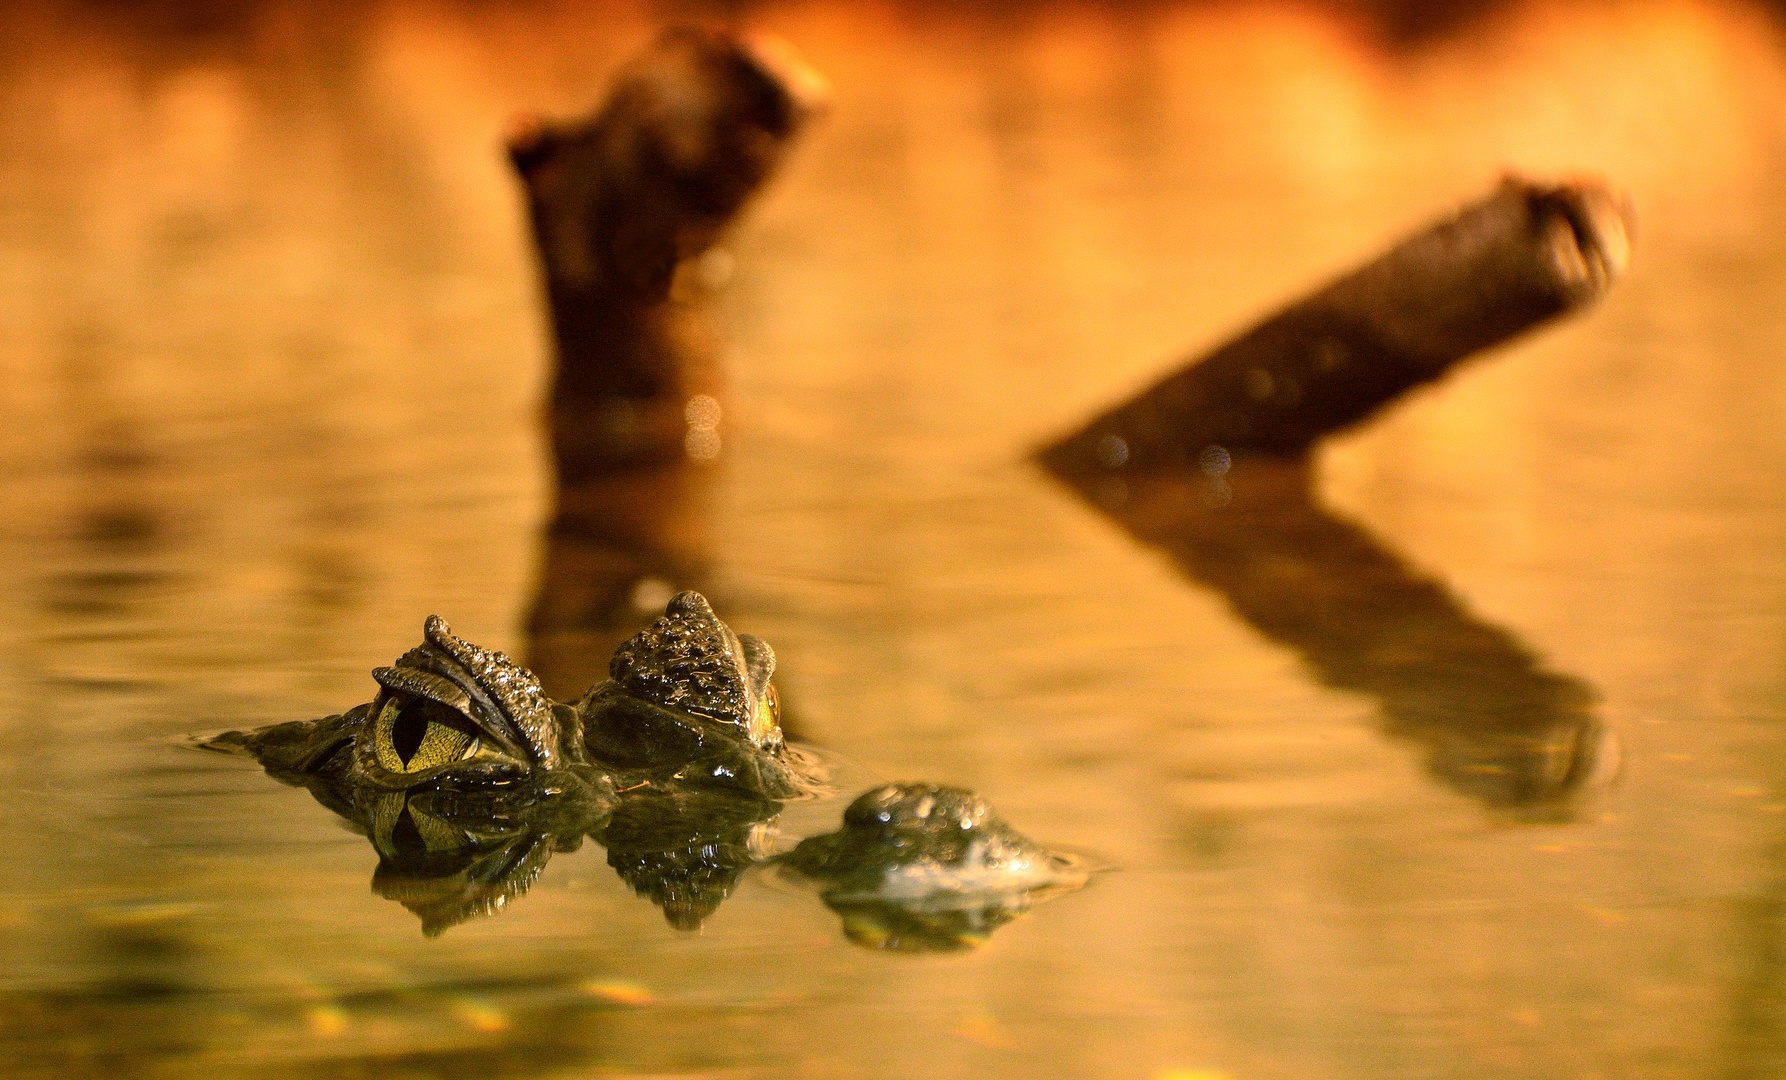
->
[[782, 784, 1086, 951]]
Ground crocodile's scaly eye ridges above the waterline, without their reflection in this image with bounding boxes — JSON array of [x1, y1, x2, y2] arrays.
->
[[209, 593, 813, 800]]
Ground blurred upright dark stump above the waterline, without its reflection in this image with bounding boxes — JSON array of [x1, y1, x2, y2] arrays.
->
[[509, 29, 823, 467]]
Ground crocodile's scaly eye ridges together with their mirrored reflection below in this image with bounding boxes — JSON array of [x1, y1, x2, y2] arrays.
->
[[204, 593, 818, 935]]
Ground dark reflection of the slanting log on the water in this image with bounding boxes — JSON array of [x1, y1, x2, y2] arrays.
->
[[1056, 446, 1618, 821]]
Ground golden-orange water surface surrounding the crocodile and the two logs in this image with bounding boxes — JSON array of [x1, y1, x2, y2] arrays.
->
[[0, 0, 1786, 1080]]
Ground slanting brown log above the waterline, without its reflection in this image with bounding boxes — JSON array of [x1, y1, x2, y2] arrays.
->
[[1041, 177, 1632, 471]]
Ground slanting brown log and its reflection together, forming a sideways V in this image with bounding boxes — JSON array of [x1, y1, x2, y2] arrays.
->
[[1039, 179, 1632, 819]]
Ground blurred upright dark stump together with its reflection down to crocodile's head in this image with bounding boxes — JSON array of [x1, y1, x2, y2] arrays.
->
[[509, 29, 825, 696]]
